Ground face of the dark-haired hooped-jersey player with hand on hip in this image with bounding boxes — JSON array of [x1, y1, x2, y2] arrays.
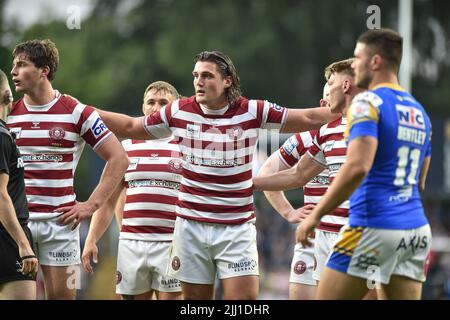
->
[[11, 53, 41, 93]]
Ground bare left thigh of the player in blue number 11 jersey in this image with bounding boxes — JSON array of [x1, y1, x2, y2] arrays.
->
[[317, 267, 369, 300]]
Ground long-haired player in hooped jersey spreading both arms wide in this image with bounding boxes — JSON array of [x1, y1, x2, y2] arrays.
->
[[95, 51, 335, 299]]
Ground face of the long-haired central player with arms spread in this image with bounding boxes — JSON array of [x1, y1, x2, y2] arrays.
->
[[192, 61, 229, 107]]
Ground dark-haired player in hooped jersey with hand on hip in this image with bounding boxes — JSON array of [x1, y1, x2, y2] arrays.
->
[[8, 40, 128, 299]]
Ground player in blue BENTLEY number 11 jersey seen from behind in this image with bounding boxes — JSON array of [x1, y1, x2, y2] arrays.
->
[[299, 29, 431, 299]]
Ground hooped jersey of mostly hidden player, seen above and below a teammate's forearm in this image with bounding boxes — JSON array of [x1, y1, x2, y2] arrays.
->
[[277, 130, 328, 210]]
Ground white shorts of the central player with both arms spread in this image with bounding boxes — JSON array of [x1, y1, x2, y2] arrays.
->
[[168, 217, 259, 284]]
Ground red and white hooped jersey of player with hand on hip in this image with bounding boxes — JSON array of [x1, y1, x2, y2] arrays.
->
[[7, 91, 111, 220]]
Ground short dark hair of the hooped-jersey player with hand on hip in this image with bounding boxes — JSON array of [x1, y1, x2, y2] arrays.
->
[[12, 39, 59, 81]]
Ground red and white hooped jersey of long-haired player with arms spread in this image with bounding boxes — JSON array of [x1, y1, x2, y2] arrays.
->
[[144, 96, 287, 224]]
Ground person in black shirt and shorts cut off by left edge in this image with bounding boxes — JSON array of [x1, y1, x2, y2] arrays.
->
[[0, 70, 38, 300]]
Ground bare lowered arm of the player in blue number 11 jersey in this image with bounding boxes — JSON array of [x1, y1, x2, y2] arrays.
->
[[297, 136, 378, 247]]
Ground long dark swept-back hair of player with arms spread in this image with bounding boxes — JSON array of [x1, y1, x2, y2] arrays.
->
[[194, 51, 242, 103]]
